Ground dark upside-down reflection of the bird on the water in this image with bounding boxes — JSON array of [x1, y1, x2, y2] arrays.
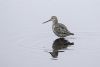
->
[[49, 38, 74, 58]]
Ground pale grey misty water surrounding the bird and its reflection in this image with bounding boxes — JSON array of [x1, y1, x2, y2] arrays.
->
[[0, 0, 100, 67]]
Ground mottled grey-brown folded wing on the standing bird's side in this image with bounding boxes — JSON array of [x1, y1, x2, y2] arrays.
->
[[54, 23, 69, 34]]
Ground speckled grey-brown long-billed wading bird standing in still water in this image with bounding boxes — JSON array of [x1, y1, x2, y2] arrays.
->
[[44, 16, 74, 37]]
